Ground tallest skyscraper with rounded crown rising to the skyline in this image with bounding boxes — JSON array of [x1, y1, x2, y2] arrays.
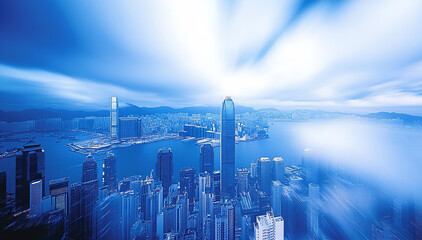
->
[[220, 97, 236, 198]]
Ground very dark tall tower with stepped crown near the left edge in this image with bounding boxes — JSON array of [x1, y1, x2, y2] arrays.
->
[[16, 141, 45, 210]]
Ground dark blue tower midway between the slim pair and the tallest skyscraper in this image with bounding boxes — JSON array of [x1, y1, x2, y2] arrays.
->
[[155, 148, 173, 198]]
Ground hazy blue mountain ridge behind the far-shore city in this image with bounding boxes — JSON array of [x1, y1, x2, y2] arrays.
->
[[0, 104, 255, 122]]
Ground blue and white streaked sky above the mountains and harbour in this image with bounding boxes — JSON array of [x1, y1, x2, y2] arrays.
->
[[0, 0, 422, 115]]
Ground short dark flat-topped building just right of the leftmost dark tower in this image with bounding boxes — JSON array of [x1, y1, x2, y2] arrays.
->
[[49, 177, 69, 215]]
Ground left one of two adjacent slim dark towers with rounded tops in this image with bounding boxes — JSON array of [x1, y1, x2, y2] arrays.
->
[[81, 154, 98, 239]]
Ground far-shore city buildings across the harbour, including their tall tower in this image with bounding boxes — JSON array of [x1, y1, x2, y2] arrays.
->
[[0, 97, 268, 145]]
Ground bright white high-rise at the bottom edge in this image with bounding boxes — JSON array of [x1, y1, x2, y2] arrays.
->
[[254, 212, 284, 240]]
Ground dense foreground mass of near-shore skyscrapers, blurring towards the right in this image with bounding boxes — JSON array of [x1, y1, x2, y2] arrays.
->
[[0, 97, 422, 240]]
